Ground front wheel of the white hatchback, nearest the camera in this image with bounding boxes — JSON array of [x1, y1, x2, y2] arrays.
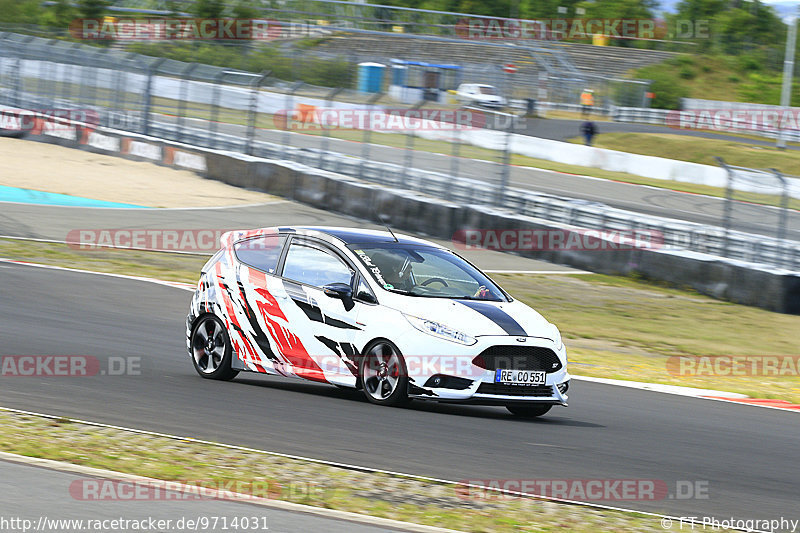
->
[[358, 340, 410, 406]]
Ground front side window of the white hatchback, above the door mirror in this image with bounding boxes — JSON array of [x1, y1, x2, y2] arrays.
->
[[283, 243, 355, 287]]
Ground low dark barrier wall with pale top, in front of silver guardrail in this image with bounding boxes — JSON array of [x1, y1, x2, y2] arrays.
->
[[14, 112, 800, 314]]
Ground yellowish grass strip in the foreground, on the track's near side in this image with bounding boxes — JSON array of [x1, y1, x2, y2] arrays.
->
[[0, 410, 720, 533]]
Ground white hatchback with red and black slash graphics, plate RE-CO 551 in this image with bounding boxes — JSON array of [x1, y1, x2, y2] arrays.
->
[[186, 227, 570, 417]]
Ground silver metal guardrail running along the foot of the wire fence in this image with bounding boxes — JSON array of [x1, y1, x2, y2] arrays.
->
[[142, 116, 800, 271]]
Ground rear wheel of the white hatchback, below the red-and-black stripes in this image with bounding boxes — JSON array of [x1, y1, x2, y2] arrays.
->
[[191, 315, 239, 381]]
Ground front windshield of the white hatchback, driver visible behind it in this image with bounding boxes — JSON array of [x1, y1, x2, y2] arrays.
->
[[350, 243, 506, 301]]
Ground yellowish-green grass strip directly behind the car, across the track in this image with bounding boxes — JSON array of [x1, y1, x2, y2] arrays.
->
[[0, 235, 800, 403]]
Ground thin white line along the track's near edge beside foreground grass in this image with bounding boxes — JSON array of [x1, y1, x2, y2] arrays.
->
[[0, 407, 732, 533]]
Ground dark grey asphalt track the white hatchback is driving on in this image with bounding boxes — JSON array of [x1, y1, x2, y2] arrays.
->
[[0, 263, 798, 520]]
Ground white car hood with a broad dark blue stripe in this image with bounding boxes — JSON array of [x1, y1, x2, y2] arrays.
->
[[387, 294, 556, 340]]
